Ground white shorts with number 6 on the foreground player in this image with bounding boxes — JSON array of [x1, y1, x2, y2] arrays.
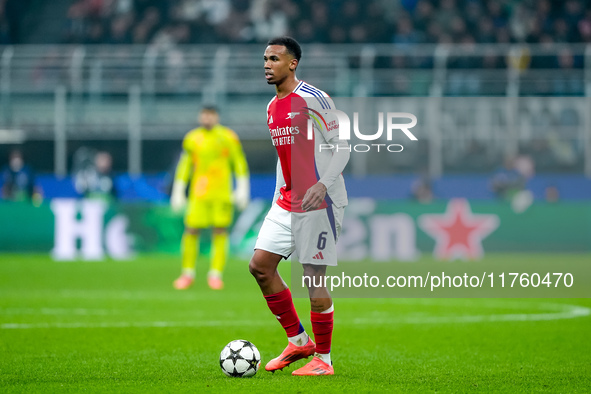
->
[[254, 204, 345, 265]]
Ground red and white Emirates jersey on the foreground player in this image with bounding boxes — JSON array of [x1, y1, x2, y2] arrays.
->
[[267, 81, 350, 212]]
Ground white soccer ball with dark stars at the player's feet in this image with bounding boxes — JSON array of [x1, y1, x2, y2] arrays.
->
[[220, 339, 261, 378]]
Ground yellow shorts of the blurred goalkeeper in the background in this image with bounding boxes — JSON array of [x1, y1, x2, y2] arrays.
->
[[185, 198, 234, 229]]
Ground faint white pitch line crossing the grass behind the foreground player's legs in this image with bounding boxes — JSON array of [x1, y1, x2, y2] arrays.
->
[[0, 304, 591, 330]]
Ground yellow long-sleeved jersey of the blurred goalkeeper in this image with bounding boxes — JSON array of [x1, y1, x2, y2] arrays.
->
[[175, 124, 248, 201]]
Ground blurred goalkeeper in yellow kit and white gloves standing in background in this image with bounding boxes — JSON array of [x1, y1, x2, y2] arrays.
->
[[170, 107, 250, 290]]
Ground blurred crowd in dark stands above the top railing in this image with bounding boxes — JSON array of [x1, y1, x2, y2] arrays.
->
[[0, 0, 591, 45]]
